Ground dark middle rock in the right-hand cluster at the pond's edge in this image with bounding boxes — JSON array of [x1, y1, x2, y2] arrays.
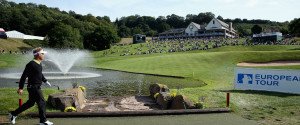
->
[[156, 92, 172, 109]]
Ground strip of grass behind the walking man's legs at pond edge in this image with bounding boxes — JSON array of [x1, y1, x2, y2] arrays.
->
[[0, 88, 59, 114]]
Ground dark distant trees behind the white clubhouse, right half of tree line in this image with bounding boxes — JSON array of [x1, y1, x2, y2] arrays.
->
[[115, 12, 300, 37]]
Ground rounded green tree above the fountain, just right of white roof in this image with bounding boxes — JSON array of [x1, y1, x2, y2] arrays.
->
[[47, 23, 83, 48]]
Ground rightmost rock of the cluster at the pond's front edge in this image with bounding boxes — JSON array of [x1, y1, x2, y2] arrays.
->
[[170, 95, 195, 109]]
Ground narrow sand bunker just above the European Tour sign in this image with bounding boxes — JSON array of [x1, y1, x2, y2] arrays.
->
[[237, 61, 300, 67]]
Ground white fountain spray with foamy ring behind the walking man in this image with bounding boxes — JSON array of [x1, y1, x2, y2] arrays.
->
[[0, 49, 101, 80]]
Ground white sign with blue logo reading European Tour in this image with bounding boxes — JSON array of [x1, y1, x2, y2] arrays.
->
[[234, 67, 300, 94]]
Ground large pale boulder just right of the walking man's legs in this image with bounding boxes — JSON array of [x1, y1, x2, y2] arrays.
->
[[47, 88, 86, 111]]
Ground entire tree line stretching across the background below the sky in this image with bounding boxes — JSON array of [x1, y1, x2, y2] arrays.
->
[[0, 0, 299, 50]]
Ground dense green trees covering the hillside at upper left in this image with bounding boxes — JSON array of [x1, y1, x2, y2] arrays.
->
[[0, 0, 120, 50]]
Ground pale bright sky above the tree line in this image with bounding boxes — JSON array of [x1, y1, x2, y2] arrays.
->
[[9, 0, 300, 22]]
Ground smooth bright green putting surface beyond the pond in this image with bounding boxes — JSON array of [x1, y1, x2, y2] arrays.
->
[[92, 48, 300, 88]]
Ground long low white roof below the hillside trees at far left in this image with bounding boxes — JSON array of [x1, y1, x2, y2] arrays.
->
[[6, 30, 44, 40]]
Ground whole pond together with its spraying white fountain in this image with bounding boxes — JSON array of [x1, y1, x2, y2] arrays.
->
[[0, 48, 204, 97]]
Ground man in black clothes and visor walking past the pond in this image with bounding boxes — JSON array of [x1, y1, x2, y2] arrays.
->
[[9, 47, 53, 125]]
